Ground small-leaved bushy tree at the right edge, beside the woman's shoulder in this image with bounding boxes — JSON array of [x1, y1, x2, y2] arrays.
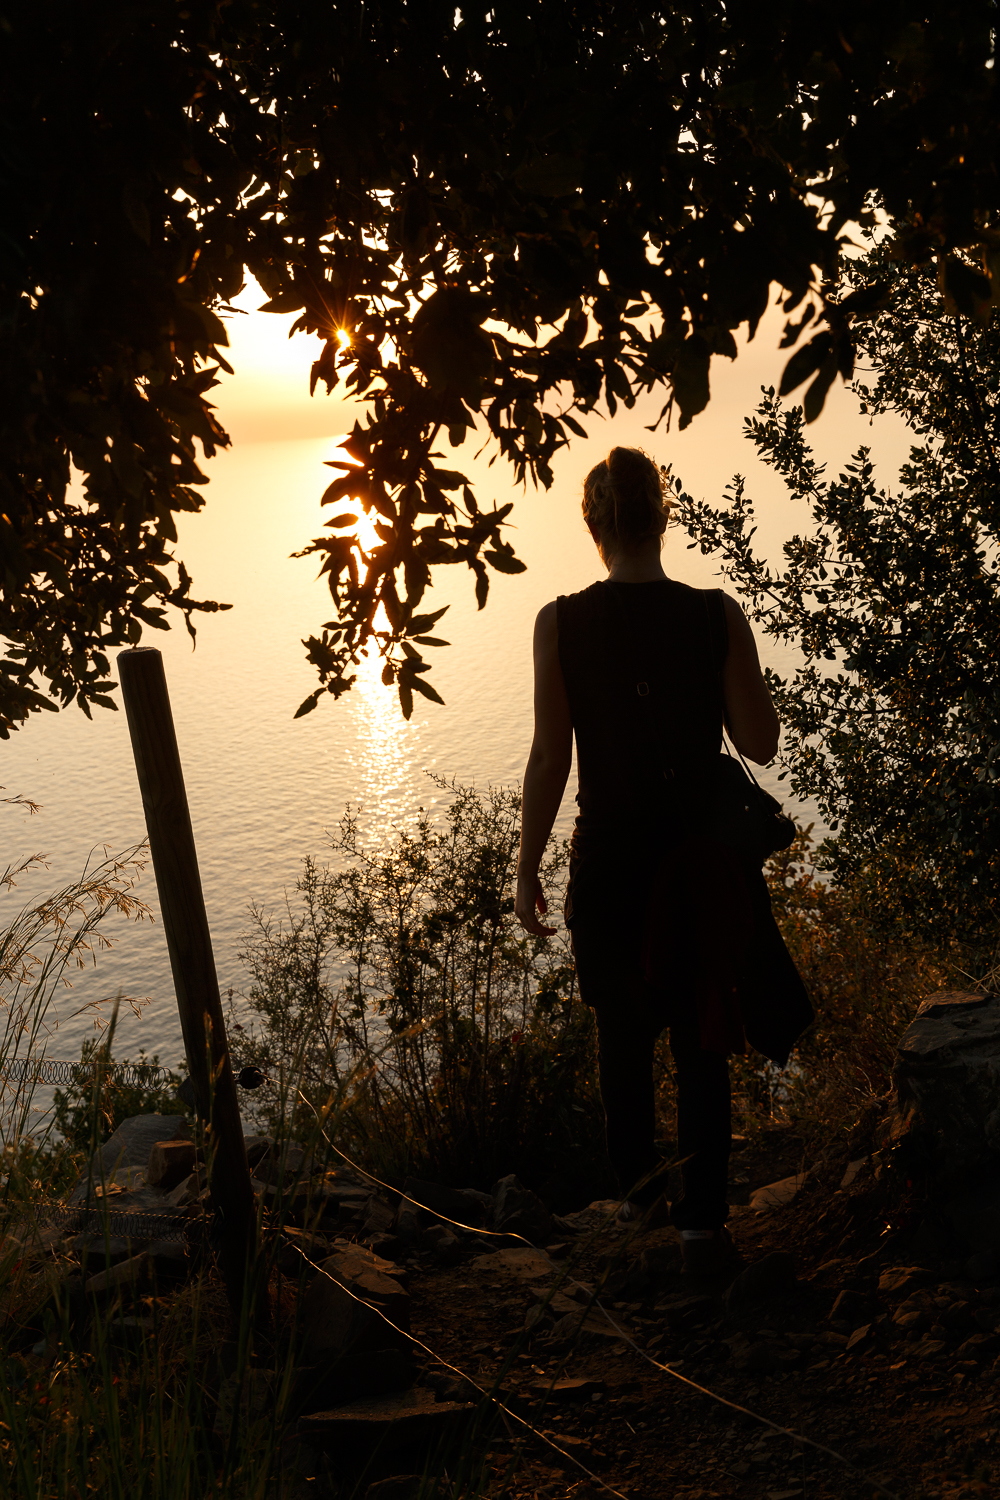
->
[[684, 252, 1000, 945]]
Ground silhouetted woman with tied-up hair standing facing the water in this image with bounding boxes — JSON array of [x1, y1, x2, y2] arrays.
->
[[516, 447, 811, 1272]]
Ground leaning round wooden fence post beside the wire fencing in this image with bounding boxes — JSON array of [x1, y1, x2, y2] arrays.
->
[[117, 647, 255, 1317]]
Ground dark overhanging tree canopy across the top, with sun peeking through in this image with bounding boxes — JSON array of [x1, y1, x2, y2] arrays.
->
[[0, 0, 1000, 735]]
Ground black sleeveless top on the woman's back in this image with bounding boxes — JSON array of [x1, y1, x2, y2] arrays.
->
[[556, 579, 727, 858]]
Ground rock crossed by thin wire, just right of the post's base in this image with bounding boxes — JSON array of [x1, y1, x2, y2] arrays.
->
[[301, 1245, 409, 1364]]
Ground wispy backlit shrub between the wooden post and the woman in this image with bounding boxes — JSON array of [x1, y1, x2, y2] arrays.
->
[[235, 786, 603, 1194]]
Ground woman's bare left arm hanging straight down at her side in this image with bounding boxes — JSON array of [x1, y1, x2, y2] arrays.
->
[[514, 605, 573, 938]]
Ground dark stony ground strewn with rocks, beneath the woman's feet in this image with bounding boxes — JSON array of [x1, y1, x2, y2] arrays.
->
[[3, 1118, 1000, 1500]]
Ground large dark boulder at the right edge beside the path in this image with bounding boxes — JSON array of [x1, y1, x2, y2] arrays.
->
[[885, 990, 1000, 1188]]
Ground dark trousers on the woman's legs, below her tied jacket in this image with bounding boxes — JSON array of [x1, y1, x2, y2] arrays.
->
[[573, 923, 732, 1229]]
